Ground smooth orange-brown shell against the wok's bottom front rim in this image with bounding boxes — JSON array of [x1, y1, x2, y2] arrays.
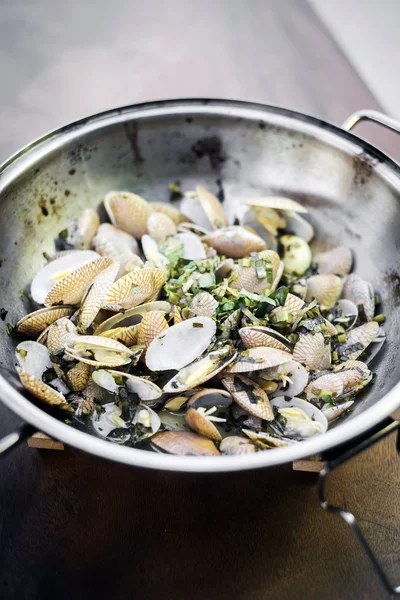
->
[[151, 431, 220, 456]]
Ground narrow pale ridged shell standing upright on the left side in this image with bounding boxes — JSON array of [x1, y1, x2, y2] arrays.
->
[[78, 262, 119, 333]]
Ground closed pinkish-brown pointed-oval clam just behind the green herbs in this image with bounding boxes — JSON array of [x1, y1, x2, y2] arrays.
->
[[202, 225, 266, 258]]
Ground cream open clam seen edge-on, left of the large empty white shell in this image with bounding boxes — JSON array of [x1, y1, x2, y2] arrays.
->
[[65, 335, 134, 367]]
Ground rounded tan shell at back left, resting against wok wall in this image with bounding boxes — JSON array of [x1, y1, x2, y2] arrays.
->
[[104, 192, 153, 240]]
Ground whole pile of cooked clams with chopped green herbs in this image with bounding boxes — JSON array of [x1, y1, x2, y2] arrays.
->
[[9, 184, 385, 456]]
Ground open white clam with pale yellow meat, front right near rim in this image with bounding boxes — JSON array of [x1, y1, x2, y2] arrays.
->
[[271, 396, 328, 439]]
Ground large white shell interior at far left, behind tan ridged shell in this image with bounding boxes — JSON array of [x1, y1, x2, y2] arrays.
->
[[31, 250, 101, 304]]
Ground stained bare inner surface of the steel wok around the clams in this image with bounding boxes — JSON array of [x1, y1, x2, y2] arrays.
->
[[0, 102, 400, 460]]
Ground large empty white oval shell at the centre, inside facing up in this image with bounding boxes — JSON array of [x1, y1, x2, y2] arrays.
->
[[146, 317, 216, 371]]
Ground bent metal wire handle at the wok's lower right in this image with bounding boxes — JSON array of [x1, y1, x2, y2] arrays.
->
[[318, 418, 400, 595]]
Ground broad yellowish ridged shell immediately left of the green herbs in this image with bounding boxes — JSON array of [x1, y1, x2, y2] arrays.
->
[[103, 268, 166, 311]]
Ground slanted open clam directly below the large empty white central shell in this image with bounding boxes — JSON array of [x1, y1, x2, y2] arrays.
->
[[163, 344, 236, 393]]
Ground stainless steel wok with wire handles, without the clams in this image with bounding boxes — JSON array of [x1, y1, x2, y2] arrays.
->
[[0, 99, 400, 592]]
